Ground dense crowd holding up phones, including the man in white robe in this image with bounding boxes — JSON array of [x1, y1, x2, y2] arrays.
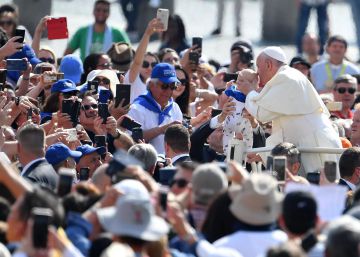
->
[[0, 0, 360, 257]]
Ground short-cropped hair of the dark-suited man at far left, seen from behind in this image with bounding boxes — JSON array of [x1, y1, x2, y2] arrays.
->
[[17, 124, 45, 156]]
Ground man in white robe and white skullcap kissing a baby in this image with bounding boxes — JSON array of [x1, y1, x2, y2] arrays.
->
[[240, 47, 341, 173]]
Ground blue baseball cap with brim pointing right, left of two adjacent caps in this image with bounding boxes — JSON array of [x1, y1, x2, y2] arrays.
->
[[45, 143, 82, 165]]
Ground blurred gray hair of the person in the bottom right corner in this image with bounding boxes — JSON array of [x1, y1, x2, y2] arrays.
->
[[325, 216, 360, 257]]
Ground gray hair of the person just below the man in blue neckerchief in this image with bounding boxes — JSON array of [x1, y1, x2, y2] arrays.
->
[[128, 144, 157, 172]]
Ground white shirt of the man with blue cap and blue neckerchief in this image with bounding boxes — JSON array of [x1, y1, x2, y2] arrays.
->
[[128, 99, 183, 154]]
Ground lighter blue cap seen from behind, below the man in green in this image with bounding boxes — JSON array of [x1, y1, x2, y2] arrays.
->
[[59, 54, 84, 84]]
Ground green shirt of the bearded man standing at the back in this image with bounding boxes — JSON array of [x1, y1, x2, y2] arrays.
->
[[69, 26, 130, 61]]
